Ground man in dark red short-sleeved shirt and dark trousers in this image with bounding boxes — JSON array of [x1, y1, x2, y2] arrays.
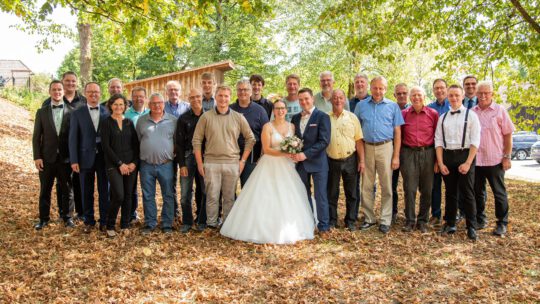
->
[[399, 87, 439, 233]]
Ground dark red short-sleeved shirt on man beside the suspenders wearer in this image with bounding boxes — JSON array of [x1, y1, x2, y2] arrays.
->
[[401, 106, 439, 147]]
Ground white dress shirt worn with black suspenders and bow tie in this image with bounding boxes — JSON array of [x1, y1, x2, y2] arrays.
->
[[435, 105, 480, 150]]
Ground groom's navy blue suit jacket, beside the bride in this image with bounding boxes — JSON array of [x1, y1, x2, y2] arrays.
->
[[291, 108, 330, 172]]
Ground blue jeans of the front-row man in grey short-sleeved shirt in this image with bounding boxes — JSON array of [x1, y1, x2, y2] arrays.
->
[[140, 160, 174, 228]]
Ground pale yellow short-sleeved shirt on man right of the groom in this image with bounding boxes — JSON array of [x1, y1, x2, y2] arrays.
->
[[326, 110, 364, 159]]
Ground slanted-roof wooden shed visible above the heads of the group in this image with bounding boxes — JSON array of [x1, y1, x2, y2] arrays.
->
[[124, 60, 234, 99]]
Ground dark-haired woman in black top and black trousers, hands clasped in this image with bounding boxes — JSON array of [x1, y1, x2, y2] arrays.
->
[[100, 94, 139, 237]]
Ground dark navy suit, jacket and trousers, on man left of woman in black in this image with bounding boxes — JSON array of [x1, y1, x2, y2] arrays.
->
[[69, 105, 109, 226]]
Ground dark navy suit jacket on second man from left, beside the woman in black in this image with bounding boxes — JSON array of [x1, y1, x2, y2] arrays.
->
[[69, 105, 109, 169]]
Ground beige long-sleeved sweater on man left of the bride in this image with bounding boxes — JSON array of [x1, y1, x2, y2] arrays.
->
[[192, 108, 255, 164]]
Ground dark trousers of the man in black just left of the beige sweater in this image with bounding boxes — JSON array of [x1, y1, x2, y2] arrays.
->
[[180, 154, 206, 226]]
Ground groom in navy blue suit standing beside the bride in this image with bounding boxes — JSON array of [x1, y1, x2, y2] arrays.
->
[[291, 88, 330, 232]]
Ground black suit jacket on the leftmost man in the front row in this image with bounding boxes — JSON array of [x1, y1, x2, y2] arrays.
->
[[32, 103, 72, 163]]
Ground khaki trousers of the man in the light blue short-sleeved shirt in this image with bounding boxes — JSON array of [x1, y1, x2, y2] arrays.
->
[[361, 141, 394, 226]]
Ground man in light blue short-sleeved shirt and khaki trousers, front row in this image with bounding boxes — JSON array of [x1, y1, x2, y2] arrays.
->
[[354, 76, 404, 234]]
